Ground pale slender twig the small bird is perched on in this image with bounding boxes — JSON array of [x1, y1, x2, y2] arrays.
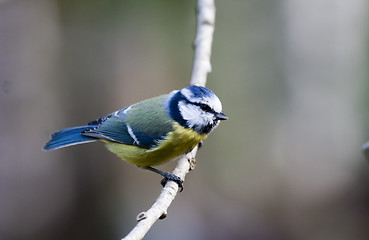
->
[[122, 0, 215, 240]]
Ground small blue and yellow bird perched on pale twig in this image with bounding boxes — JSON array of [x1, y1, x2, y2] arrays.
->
[[43, 85, 228, 191]]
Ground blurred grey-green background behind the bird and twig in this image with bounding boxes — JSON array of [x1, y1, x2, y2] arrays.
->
[[0, 0, 369, 240]]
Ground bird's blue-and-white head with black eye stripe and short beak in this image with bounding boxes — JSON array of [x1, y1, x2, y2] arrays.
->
[[168, 86, 228, 134]]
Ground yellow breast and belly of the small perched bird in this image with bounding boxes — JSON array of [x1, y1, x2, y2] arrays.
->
[[104, 122, 207, 166]]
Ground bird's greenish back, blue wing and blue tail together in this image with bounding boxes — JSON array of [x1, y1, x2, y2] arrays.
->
[[44, 95, 173, 151]]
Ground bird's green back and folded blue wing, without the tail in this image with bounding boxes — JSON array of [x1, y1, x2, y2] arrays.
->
[[82, 97, 172, 149]]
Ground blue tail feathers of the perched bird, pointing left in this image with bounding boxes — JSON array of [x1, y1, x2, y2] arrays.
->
[[43, 125, 97, 151]]
